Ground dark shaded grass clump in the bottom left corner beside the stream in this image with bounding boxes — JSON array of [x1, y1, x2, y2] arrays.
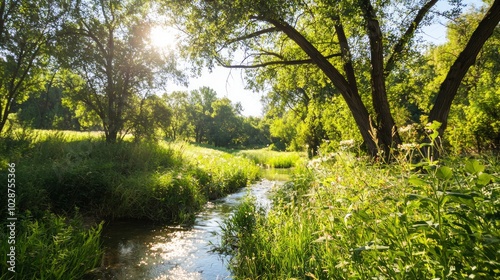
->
[[0, 213, 102, 279]]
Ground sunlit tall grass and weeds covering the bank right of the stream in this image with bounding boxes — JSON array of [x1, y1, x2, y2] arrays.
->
[[219, 153, 500, 279]]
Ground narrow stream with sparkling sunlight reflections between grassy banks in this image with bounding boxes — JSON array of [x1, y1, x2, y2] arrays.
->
[[91, 171, 286, 280]]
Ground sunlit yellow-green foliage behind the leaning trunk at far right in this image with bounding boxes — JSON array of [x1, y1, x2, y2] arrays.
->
[[417, 6, 500, 153]]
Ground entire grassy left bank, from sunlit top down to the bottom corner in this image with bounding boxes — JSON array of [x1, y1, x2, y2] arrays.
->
[[0, 131, 259, 279]]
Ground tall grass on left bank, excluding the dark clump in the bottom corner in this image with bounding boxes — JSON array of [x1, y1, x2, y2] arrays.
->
[[0, 132, 259, 222]]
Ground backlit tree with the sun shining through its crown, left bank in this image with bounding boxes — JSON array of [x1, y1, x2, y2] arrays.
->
[[59, 0, 182, 143]]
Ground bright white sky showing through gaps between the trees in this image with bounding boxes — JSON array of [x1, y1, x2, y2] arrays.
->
[[167, 0, 482, 116]]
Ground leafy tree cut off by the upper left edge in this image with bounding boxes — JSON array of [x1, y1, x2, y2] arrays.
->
[[0, 0, 65, 135]]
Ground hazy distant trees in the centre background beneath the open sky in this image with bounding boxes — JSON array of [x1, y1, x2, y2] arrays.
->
[[164, 87, 268, 148]]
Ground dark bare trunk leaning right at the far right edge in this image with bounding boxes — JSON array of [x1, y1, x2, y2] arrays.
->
[[429, 0, 500, 135]]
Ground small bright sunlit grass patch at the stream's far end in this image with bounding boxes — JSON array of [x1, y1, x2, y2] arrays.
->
[[236, 149, 305, 168]]
